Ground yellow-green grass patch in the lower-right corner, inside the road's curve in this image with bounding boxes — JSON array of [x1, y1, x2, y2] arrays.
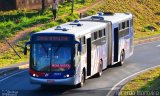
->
[[120, 67, 160, 96]]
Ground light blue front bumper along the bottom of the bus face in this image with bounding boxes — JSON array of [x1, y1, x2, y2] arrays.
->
[[30, 77, 76, 85]]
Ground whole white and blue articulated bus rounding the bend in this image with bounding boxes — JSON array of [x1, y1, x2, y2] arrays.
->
[[24, 12, 133, 87]]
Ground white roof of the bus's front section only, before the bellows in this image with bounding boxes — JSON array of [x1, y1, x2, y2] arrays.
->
[[34, 21, 107, 37]]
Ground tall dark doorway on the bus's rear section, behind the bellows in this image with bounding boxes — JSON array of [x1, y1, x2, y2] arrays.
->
[[114, 27, 119, 62]]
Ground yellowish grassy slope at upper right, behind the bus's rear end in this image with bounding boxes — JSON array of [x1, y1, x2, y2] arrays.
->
[[86, 0, 160, 39]]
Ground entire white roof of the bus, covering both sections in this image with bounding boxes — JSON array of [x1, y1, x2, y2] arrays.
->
[[34, 13, 133, 37]]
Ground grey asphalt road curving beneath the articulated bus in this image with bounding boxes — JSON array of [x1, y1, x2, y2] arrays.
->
[[0, 41, 160, 96]]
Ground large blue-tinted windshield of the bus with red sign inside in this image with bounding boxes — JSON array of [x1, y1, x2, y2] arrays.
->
[[31, 43, 72, 72]]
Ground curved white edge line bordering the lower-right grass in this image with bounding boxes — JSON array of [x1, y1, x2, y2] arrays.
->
[[106, 65, 160, 96]]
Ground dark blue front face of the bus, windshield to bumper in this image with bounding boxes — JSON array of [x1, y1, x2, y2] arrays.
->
[[29, 33, 80, 85]]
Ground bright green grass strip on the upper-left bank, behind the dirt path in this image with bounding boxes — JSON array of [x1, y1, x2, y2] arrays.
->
[[0, 0, 95, 40]]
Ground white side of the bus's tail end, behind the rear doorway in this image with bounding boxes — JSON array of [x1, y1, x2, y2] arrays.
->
[[114, 17, 134, 65]]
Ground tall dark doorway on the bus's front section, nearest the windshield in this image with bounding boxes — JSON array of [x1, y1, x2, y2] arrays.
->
[[87, 38, 92, 76]]
